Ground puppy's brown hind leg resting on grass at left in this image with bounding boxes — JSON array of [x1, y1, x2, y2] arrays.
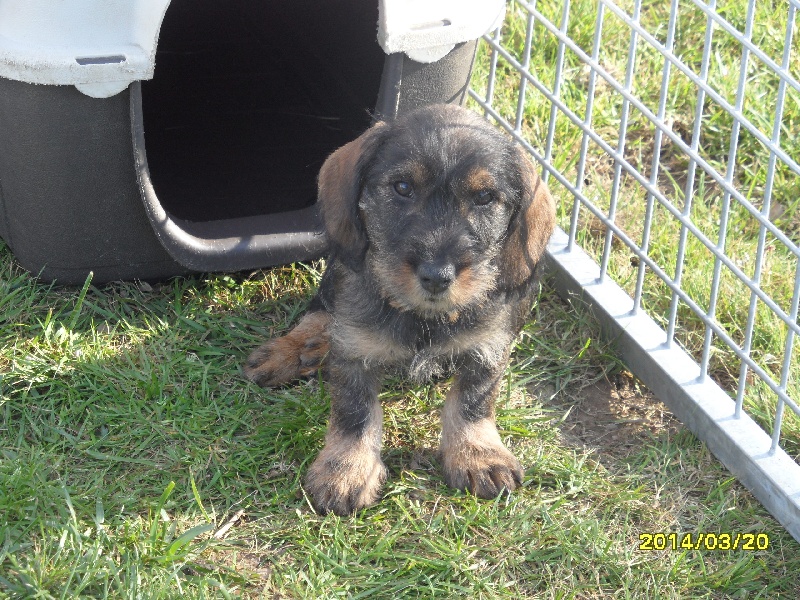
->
[[243, 310, 331, 387]]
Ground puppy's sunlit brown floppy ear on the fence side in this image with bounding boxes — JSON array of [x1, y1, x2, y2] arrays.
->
[[499, 147, 556, 290]]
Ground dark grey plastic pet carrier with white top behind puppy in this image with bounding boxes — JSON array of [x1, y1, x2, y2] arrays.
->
[[0, 0, 504, 284]]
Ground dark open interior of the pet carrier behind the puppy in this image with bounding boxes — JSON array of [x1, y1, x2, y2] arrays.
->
[[142, 0, 384, 221]]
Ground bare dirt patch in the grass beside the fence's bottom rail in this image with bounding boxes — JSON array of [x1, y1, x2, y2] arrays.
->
[[548, 372, 683, 461]]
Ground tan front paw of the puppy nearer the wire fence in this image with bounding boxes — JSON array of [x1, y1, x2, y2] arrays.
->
[[442, 441, 523, 498]]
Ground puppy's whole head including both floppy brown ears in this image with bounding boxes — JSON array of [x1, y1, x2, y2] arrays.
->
[[319, 105, 555, 316]]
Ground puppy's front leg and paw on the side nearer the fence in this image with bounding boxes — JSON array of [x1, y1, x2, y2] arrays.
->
[[440, 357, 523, 498]]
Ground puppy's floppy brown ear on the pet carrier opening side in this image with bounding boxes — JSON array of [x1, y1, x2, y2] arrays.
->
[[318, 122, 383, 270]]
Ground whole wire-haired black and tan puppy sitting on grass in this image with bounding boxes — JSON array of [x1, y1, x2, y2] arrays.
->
[[245, 105, 555, 515]]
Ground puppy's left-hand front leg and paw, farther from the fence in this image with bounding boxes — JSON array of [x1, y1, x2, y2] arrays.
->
[[305, 357, 386, 515]]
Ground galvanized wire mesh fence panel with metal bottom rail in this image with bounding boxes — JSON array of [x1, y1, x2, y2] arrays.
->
[[470, 0, 800, 540]]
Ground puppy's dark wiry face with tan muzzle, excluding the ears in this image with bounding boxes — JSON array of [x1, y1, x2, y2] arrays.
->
[[359, 113, 520, 315]]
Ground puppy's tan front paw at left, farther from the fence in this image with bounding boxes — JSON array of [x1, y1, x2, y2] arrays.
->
[[305, 443, 387, 516]]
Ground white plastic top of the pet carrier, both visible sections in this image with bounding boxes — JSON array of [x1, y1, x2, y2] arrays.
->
[[0, 0, 505, 98]]
